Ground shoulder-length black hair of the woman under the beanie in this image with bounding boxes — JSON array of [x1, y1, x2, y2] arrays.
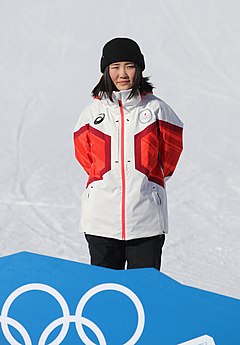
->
[[92, 64, 154, 102]]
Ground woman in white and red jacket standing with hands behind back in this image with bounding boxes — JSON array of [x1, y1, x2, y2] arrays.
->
[[74, 38, 183, 270]]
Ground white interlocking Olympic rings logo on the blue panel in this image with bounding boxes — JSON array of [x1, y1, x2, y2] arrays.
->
[[0, 283, 145, 345]]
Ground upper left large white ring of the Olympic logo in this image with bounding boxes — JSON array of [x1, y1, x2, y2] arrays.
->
[[1, 283, 70, 345]]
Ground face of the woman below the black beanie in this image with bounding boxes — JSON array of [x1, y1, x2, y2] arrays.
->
[[109, 61, 136, 91]]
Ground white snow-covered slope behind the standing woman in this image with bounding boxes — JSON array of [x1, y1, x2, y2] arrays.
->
[[0, 0, 240, 298]]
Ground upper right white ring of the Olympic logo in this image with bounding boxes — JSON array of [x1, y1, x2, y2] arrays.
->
[[75, 283, 145, 345]]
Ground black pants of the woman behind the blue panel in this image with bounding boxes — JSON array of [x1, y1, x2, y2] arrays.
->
[[85, 234, 165, 270]]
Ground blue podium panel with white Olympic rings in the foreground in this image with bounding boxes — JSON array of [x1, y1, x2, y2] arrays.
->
[[0, 253, 240, 345]]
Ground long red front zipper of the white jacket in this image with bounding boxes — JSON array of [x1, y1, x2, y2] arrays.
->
[[118, 101, 126, 240]]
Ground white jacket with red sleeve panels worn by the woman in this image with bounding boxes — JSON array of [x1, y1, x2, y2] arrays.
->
[[74, 90, 183, 240]]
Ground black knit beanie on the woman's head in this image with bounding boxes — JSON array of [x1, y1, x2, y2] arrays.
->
[[100, 37, 145, 73]]
